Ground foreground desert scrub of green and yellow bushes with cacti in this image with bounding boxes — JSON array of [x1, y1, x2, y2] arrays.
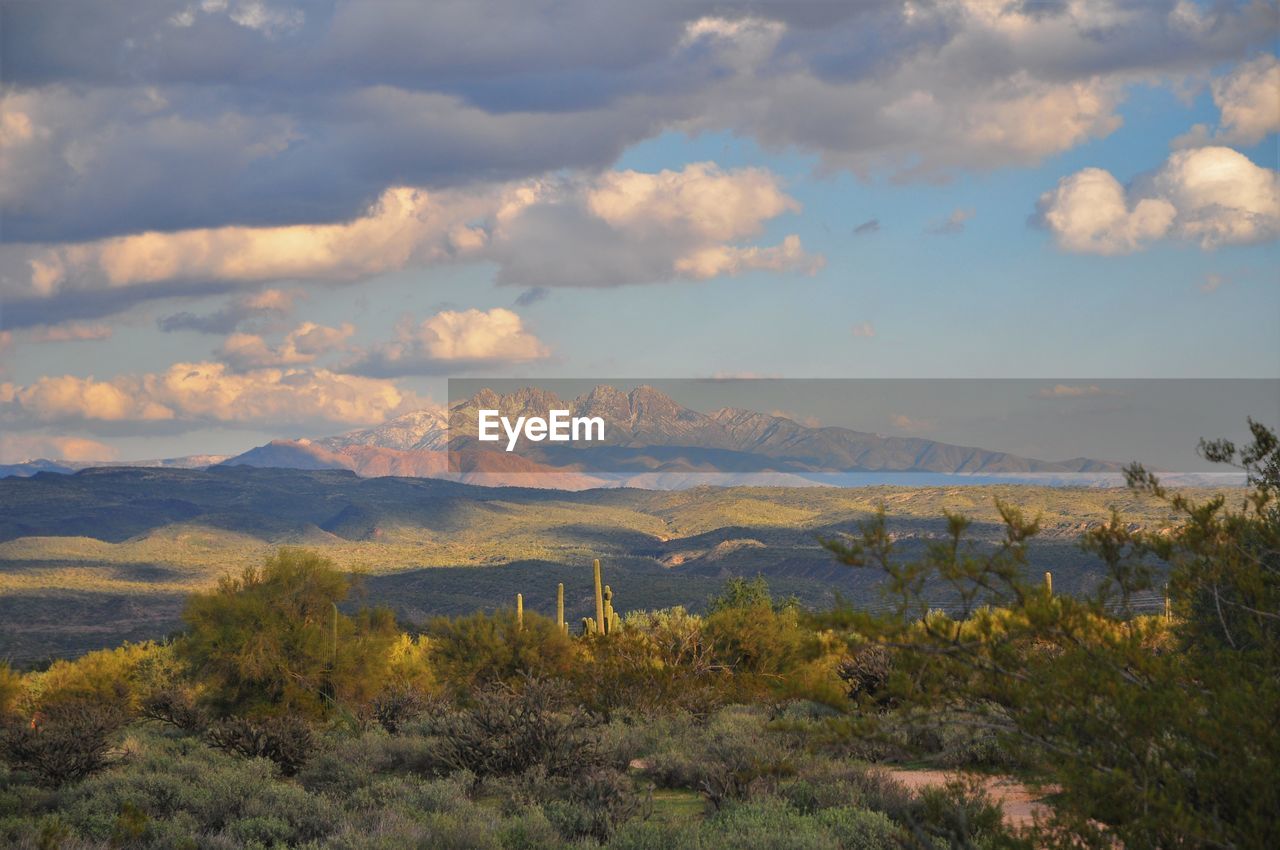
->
[[0, 425, 1280, 850]]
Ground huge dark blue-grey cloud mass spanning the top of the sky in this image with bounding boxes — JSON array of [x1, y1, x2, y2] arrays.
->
[[0, 0, 1275, 242]]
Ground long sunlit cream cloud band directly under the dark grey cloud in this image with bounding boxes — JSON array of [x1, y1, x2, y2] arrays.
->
[[0, 163, 820, 322]]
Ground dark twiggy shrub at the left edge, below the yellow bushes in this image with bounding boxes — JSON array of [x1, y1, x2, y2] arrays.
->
[[0, 699, 127, 786]]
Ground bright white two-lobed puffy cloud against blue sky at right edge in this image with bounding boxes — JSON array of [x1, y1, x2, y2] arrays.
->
[[1038, 146, 1280, 255]]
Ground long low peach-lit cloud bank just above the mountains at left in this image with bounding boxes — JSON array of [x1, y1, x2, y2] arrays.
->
[[0, 362, 424, 430]]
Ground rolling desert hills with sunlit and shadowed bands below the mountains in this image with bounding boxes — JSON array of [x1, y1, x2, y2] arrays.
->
[[0, 467, 1187, 658]]
